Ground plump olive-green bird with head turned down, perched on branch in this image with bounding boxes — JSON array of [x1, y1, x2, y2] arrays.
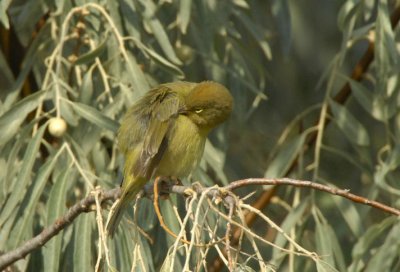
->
[[107, 81, 233, 236]]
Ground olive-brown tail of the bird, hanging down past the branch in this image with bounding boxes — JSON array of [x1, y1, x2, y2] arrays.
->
[[106, 178, 146, 238]]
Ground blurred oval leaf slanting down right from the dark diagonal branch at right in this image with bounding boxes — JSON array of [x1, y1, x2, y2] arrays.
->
[[329, 100, 370, 146]]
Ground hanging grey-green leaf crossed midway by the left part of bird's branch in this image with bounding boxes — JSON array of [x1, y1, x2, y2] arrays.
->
[[42, 167, 72, 272]]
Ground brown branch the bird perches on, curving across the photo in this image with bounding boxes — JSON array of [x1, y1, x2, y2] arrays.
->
[[0, 178, 400, 271]]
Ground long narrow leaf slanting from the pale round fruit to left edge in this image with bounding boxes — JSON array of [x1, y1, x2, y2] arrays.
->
[[0, 125, 47, 226]]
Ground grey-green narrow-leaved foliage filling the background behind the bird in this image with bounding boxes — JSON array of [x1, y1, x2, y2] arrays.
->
[[0, 0, 400, 271]]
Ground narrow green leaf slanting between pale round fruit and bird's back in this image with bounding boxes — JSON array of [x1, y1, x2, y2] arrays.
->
[[71, 102, 119, 131]]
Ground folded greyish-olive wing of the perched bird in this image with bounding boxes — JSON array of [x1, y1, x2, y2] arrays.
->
[[132, 86, 180, 178]]
